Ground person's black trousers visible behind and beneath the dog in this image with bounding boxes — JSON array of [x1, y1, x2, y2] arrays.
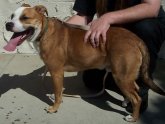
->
[[83, 18, 165, 97]]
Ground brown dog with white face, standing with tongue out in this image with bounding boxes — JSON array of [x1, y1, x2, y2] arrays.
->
[[6, 4, 165, 122]]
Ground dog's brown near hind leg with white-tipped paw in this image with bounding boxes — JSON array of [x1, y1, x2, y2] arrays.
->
[[112, 63, 141, 122]]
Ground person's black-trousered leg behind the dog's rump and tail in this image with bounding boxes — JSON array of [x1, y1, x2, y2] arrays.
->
[[126, 19, 165, 112]]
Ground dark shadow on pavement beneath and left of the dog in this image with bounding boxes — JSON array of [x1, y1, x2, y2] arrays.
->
[[0, 67, 126, 115]]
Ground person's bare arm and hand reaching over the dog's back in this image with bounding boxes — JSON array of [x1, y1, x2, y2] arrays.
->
[[84, 0, 161, 47]]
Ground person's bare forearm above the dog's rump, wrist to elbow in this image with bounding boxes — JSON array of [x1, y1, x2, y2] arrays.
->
[[102, 2, 160, 24]]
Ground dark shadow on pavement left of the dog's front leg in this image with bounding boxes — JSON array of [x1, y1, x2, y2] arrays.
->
[[0, 67, 52, 104]]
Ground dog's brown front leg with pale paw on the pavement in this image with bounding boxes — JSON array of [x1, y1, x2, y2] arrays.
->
[[48, 70, 64, 113]]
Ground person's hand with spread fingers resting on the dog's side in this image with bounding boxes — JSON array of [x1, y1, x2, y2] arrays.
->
[[84, 16, 110, 48]]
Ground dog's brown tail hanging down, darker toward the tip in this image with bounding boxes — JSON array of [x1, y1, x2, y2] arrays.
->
[[139, 41, 165, 96]]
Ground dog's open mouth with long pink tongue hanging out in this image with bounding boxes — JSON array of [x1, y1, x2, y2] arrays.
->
[[4, 28, 34, 52]]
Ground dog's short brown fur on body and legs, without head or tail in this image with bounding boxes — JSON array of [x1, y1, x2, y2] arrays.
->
[[40, 19, 143, 120]]
